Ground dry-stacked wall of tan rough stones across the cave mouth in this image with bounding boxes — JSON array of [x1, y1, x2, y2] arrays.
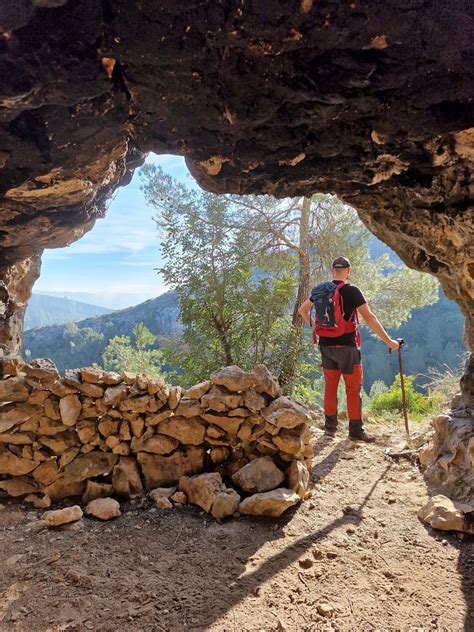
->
[[0, 357, 312, 517]]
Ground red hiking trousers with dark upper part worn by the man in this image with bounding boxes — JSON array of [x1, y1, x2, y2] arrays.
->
[[321, 347, 362, 421]]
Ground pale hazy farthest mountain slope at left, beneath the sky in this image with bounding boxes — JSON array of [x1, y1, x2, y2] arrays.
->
[[25, 292, 112, 329]]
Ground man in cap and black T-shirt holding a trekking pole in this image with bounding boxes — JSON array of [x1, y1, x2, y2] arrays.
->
[[298, 257, 398, 443]]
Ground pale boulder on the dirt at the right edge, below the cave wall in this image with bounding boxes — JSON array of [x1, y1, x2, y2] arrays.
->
[[418, 495, 474, 534]]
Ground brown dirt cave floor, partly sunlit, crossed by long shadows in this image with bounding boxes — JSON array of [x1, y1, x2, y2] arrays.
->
[[0, 428, 474, 632]]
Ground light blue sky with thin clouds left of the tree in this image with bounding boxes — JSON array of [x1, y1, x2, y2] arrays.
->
[[33, 154, 196, 308]]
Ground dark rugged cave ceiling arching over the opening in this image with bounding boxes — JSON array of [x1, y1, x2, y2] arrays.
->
[[0, 0, 474, 346]]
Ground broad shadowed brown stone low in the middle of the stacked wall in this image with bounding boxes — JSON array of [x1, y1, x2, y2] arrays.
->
[[137, 447, 205, 489]]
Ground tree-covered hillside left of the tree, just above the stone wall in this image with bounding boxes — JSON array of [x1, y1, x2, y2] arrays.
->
[[23, 292, 181, 371]]
